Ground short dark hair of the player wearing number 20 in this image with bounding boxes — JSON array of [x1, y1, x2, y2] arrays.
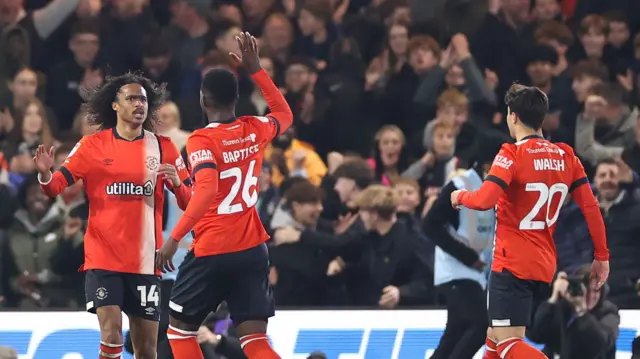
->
[[504, 84, 549, 131]]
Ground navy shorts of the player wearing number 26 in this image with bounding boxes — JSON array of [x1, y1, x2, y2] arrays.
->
[[169, 244, 275, 324]]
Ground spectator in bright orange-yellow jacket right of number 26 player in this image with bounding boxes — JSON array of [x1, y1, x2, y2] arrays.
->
[[264, 127, 327, 186]]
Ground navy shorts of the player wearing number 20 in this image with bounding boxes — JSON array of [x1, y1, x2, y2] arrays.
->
[[488, 270, 551, 327]]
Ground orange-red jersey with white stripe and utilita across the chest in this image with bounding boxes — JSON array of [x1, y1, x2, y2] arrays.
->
[[42, 128, 189, 274]]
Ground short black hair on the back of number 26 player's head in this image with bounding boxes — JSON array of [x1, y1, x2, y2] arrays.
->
[[200, 69, 238, 108]]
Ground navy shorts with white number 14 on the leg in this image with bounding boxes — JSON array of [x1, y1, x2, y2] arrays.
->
[[84, 269, 160, 322]]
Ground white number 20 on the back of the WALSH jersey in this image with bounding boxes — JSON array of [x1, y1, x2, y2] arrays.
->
[[520, 182, 569, 231]]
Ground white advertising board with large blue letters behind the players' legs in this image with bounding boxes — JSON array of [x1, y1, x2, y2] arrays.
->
[[0, 310, 640, 359]]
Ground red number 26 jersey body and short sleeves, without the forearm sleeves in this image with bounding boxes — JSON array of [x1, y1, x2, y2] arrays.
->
[[182, 116, 280, 256]]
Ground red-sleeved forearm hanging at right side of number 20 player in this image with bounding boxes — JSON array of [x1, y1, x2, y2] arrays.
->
[[571, 183, 609, 261]]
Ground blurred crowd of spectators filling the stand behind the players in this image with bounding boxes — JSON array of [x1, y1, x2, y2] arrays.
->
[[0, 0, 640, 358]]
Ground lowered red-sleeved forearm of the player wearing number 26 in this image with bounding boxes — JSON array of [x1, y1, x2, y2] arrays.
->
[[171, 168, 218, 241]]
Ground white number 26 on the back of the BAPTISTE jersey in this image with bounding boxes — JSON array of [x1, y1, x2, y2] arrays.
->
[[218, 160, 258, 214]]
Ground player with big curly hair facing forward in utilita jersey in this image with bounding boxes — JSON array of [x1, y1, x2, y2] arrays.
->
[[33, 73, 191, 359]]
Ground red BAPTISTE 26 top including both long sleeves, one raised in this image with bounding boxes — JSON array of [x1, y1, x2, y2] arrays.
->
[[166, 70, 293, 257]]
